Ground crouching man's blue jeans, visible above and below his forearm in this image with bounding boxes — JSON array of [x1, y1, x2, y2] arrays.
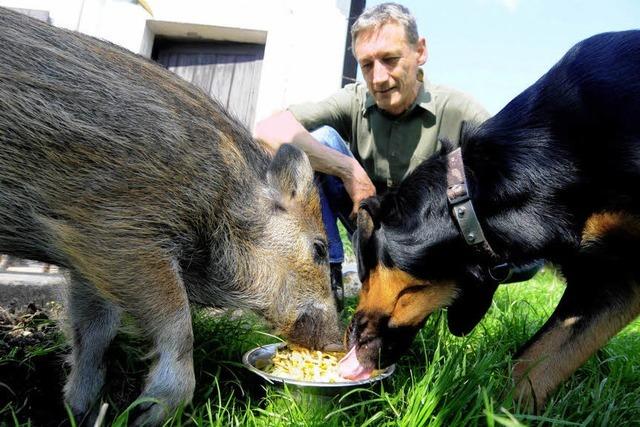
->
[[311, 126, 355, 263]]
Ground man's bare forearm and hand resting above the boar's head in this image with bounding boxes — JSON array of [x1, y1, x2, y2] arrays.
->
[[254, 111, 376, 214]]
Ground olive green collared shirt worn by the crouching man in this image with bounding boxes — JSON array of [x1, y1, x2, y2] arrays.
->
[[289, 82, 489, 187]]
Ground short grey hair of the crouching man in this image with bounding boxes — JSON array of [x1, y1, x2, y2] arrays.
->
[[351, 2, 420, 54]]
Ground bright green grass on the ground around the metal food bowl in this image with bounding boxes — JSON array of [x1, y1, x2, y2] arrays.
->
[[0, 267, 640, 426]]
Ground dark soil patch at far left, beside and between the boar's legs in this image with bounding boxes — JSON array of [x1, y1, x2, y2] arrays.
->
[[0, 304, 156, 427]]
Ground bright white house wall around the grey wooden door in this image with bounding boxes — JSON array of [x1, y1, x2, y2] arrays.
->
[[0, 0, 350, 129]]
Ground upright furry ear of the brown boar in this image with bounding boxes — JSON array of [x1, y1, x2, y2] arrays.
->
[[267, 144, 315, 206]]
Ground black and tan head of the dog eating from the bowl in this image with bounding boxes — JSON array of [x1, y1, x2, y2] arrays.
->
[[345, 196, 497, 369]]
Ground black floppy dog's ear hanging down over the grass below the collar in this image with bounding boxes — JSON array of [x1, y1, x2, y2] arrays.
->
[[447, 277, 498, 337]]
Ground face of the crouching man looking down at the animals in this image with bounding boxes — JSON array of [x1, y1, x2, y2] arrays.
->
[[354, 23, 427, 115]]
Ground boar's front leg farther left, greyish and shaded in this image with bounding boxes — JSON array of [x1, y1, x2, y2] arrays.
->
[[64, 273, 121, 425]]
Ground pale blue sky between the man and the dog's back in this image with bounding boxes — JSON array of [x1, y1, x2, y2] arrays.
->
[[367, 0, 640, 114]]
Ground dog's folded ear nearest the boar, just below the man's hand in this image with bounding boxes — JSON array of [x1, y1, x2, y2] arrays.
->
[[352, 197, 380, 283]]
